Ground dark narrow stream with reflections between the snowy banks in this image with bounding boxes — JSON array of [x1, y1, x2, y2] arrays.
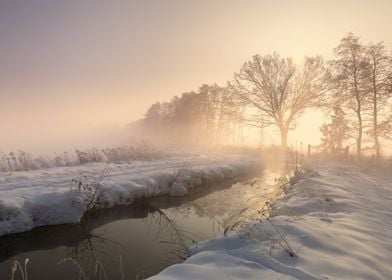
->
[[0, 165, 287, 280]]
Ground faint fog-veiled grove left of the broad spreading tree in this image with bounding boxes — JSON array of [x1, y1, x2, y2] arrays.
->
[[135, 84, 245, 145]]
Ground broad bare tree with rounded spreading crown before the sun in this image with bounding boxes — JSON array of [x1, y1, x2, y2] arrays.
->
[[229, 53, 327, 147]]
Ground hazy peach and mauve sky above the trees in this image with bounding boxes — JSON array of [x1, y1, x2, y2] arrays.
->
[[0, 0, 392, 153]]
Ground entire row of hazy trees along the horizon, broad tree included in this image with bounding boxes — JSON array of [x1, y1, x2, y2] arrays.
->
[[137, 33, 392, 157]]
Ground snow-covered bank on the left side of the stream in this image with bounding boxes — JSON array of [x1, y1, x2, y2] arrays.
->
[[0, 155, 256, 236]]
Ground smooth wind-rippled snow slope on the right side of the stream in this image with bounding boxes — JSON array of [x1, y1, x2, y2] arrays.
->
[[150, 163, 392, 280]]
